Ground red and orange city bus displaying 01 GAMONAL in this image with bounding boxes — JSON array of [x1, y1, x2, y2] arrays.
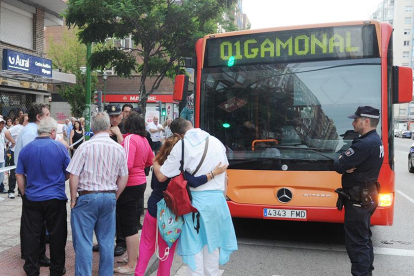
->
[[174, 21, 412, 225]]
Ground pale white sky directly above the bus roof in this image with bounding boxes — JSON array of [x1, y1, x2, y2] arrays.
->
[[243, 0, 382, 29]]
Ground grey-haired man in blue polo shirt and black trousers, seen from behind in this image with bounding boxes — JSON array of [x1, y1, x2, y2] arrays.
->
[[16, 117, 70, 275]]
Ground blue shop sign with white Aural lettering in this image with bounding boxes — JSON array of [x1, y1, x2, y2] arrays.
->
[[2, 49, 52, 78]]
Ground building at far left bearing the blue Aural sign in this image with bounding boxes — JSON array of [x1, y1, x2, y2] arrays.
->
[[0, 0, 76, 117]]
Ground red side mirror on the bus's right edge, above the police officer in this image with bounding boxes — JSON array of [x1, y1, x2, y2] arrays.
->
[[392, 66, 413, 104]]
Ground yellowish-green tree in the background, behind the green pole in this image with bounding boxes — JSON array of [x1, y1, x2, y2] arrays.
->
[[48, 26, 97, 117]]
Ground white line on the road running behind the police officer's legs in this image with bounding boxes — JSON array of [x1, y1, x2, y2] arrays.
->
[[238, 240, 414, 257]]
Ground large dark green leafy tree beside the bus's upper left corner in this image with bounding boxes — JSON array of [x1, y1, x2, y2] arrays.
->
[[65, 0, 236, 112]]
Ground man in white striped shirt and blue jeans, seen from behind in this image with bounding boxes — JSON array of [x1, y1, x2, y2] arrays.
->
[[66, 112, 128, 275]]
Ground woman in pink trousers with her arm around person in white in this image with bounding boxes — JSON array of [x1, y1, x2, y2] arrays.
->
[[135, 135, 227, 276]]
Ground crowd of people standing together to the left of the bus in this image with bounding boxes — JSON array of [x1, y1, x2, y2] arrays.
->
[[0, 103, 237, 275]]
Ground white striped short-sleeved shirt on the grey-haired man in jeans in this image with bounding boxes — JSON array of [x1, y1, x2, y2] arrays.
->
[[66, 132, 128, 191]]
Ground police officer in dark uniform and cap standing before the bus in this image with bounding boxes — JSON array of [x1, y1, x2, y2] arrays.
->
[[334, 106, 384, 276]]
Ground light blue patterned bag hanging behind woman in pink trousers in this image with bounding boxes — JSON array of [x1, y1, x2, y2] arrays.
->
[[155, 199, 184, 261]]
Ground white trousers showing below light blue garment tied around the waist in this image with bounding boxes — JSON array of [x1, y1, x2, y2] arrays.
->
[[187, 245, 219, 276]]
